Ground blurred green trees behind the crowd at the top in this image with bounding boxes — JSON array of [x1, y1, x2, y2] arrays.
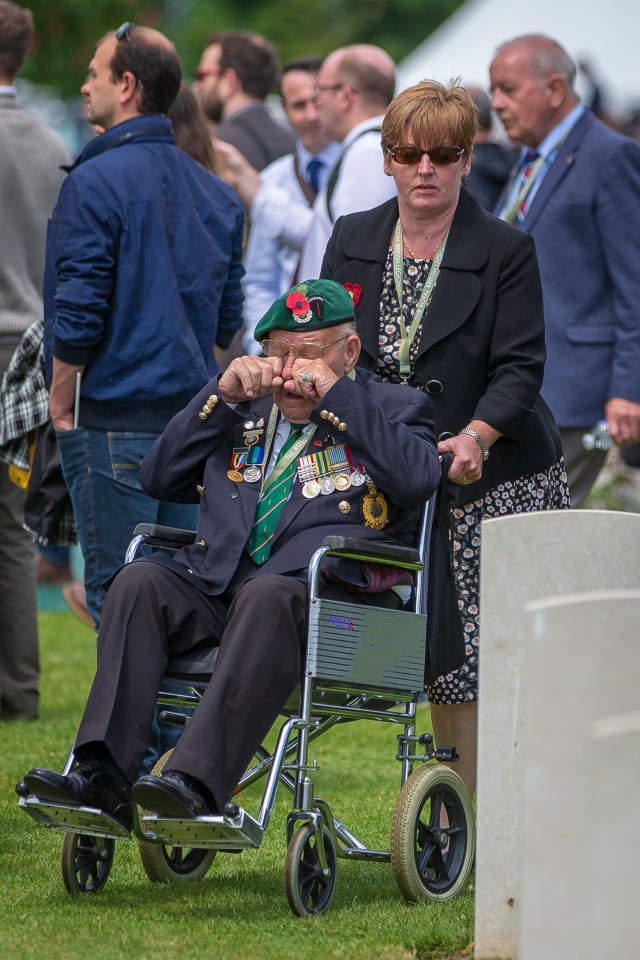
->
[[18, 0, 463, 96]]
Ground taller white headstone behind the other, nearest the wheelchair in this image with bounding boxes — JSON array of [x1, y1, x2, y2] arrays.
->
[[475, 510, 640, 960]]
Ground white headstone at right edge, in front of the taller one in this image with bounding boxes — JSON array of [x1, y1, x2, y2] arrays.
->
[[517, 590, 640, 960]]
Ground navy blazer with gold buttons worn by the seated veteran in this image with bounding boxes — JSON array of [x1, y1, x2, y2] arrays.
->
[[140, 371, 441, 596]]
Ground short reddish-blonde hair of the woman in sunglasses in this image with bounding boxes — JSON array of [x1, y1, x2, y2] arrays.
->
[[382, 80, 478, 158]]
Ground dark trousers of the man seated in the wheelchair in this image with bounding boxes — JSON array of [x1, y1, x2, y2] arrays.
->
[[76, 560, 384, 809]]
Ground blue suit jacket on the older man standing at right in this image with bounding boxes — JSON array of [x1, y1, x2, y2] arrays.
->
[[500, 110, 640, 427]]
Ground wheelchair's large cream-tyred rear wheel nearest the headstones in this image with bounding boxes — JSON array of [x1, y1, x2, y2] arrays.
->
[[391, 764, 475, 903]]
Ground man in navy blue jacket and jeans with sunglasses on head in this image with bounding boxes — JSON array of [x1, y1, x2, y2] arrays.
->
[[45, 23, 243, 626]]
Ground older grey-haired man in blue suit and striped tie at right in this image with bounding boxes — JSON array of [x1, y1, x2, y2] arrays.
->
[[490, 35, 640, 507]]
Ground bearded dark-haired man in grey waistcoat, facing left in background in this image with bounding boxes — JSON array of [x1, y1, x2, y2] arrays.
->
[[194, 30, 294, 170]]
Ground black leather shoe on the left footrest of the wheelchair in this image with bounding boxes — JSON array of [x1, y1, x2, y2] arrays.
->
[[23, 760, 133, 830]]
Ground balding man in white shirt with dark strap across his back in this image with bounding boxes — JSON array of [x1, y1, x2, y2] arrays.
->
[[299, 43, 395, 277]]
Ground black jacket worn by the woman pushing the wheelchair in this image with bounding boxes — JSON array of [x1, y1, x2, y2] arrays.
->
[[321, 189, 562, 502]]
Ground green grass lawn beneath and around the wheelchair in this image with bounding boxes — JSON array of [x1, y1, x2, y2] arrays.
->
[[0, 613, 473, 960]]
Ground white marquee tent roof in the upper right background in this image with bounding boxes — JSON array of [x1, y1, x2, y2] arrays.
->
[[397, 0, 640, 112]]
